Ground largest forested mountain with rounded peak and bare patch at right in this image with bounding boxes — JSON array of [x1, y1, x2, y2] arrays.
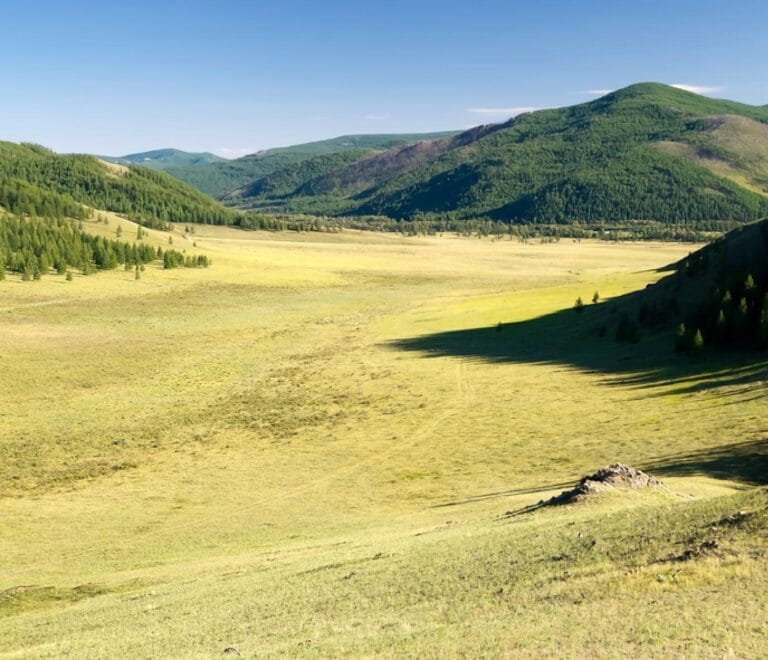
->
[[231, 83, 768, 224]]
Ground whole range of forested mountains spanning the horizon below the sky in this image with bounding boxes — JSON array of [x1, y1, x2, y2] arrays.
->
[[6, 83, 768, 229]]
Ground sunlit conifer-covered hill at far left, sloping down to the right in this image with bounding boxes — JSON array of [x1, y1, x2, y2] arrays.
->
[[0, 142, 243, 228]]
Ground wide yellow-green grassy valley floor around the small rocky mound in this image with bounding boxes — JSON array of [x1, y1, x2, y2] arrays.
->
[[0, 223, 768, 657]]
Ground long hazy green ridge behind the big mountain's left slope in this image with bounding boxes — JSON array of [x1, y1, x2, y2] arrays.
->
[[166, 131, 456, 200]]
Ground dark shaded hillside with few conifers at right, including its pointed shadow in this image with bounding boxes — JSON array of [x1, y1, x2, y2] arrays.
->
[[396, 220, 768, 378]]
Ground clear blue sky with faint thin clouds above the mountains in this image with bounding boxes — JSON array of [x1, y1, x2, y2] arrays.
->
[[0, 0, 768, 156]]
